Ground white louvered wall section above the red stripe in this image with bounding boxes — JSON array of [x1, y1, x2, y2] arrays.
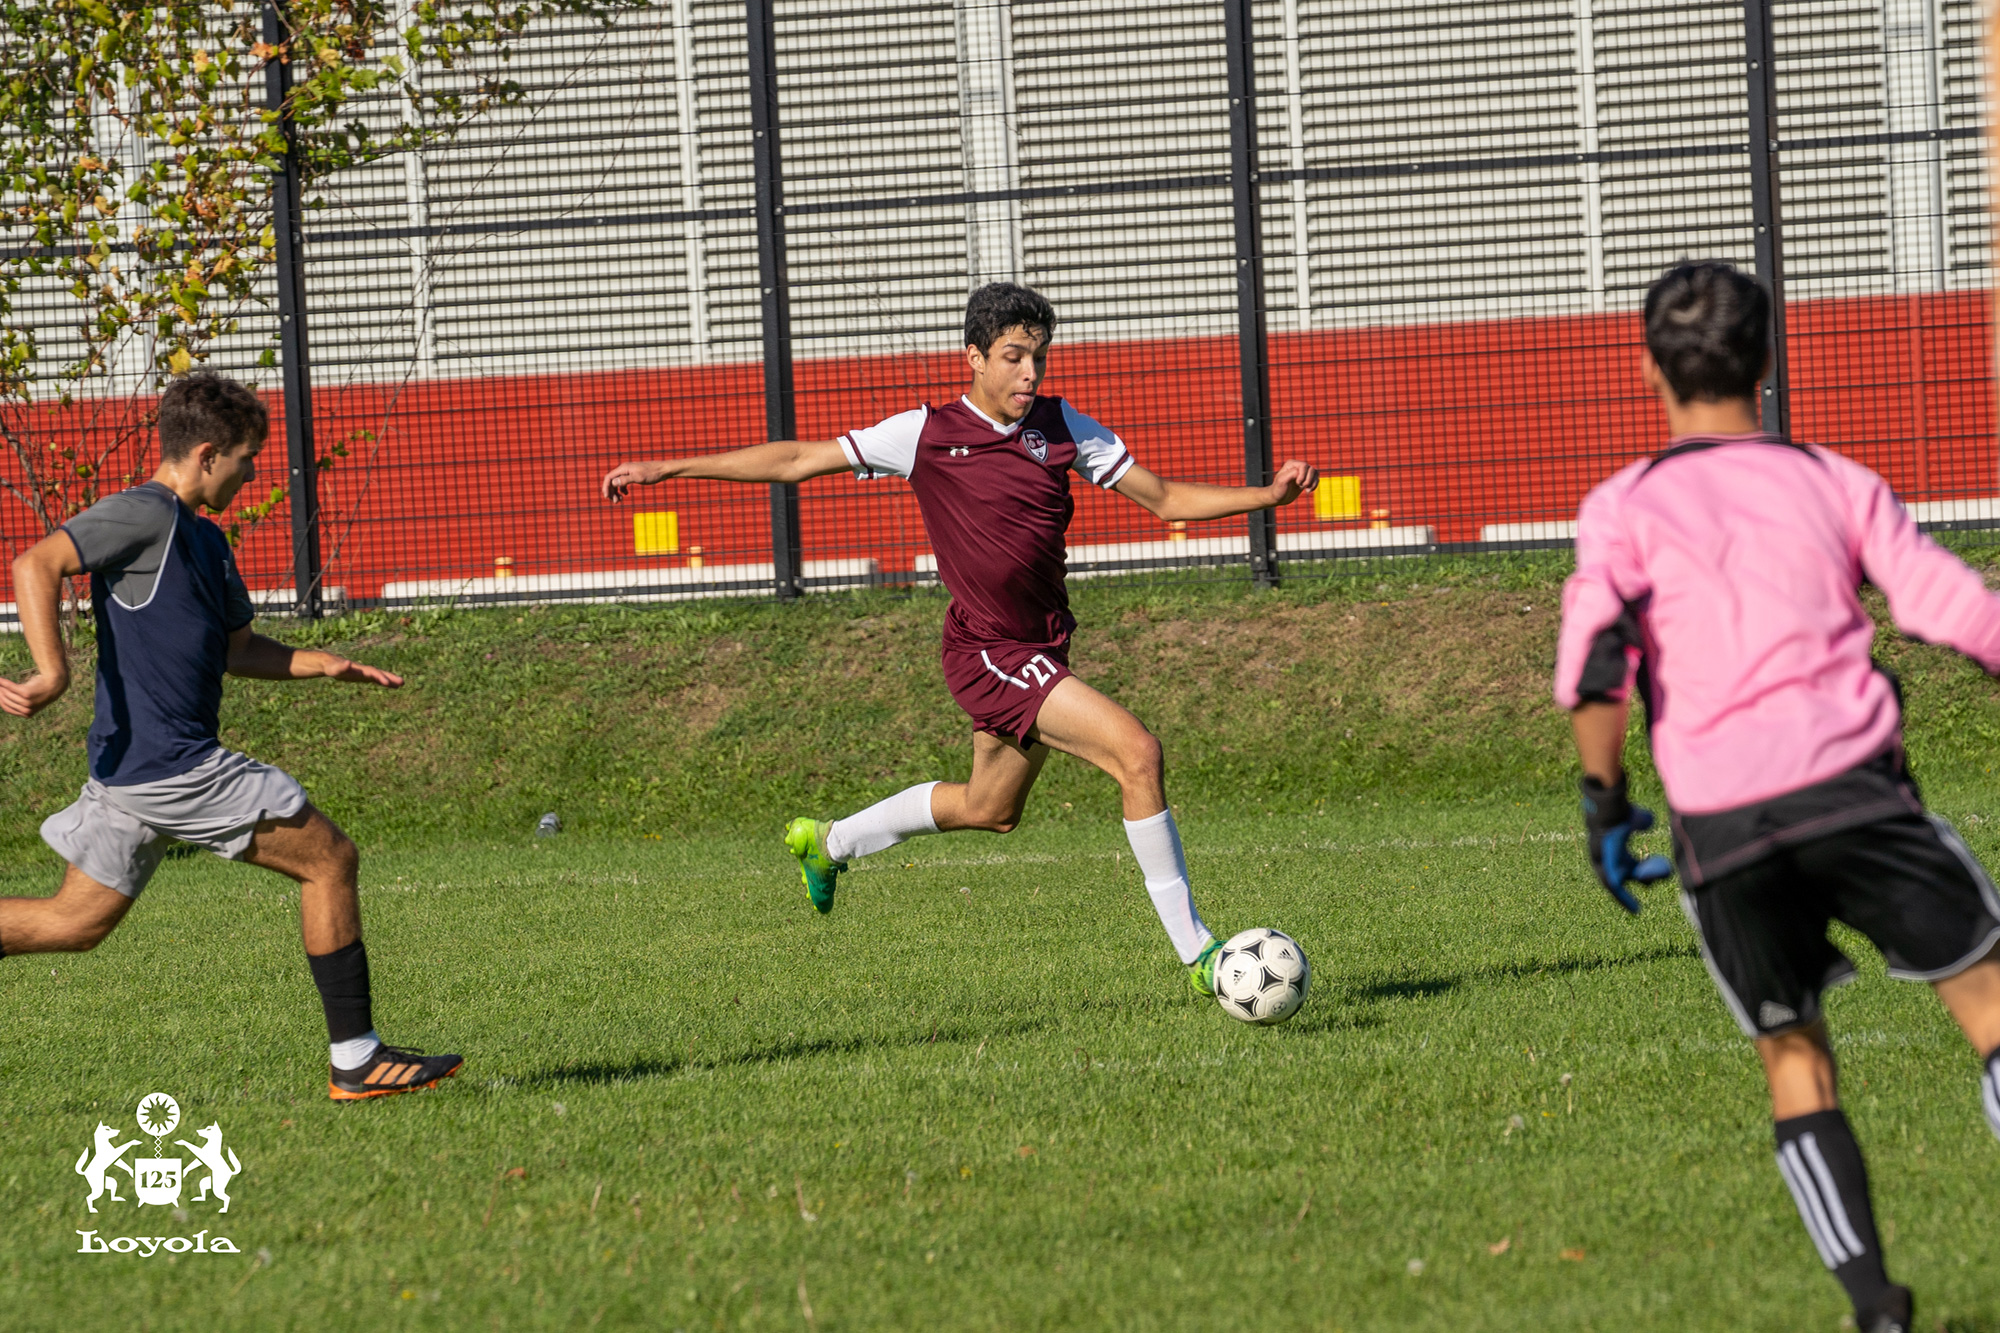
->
[[7, 0, 1992, 384]]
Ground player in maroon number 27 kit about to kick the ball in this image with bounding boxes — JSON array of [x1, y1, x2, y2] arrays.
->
[[604, 282, 1318, 995]]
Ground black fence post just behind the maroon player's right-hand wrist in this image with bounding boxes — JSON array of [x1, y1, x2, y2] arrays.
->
[[1222, 0, 1278, 588]]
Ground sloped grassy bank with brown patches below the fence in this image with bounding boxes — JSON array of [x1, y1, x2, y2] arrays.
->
[[0, 570, 2000, 861]]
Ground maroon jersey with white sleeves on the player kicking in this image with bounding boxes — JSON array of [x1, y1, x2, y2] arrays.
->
[[840, 398, 1132, 644]]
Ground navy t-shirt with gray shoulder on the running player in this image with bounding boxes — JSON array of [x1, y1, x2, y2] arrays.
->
[[62, 482, 256, 787]]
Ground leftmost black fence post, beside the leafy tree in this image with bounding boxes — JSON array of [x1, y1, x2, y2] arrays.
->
[[264, 0, 322, 620]]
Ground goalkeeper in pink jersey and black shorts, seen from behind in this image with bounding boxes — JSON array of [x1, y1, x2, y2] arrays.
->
[[1556, 264, 2000, 1333]]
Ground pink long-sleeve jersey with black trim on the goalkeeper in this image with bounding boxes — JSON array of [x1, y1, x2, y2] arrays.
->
[[1556, 434, 2000, 815]]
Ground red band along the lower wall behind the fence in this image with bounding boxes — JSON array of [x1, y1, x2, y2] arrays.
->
[[0, 292, 2000, 598]]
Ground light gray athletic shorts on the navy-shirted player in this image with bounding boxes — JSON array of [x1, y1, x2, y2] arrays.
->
[[42, 749, 306, 899]]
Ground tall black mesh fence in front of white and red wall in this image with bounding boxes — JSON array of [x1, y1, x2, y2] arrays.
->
[[0, 0, 2000, 606]]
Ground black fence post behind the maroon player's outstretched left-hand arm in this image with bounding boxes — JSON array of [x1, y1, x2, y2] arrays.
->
[[744, 0, 804, 602]]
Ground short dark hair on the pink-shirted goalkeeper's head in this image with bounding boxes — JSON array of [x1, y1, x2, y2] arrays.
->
[[1646, 260, 1770, 402]]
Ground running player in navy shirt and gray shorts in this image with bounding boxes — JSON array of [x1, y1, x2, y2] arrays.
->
[[0, 374, 460, 1101]]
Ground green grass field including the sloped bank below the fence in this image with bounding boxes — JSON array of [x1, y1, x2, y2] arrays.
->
[[0, 560, 2000, 1333]]
